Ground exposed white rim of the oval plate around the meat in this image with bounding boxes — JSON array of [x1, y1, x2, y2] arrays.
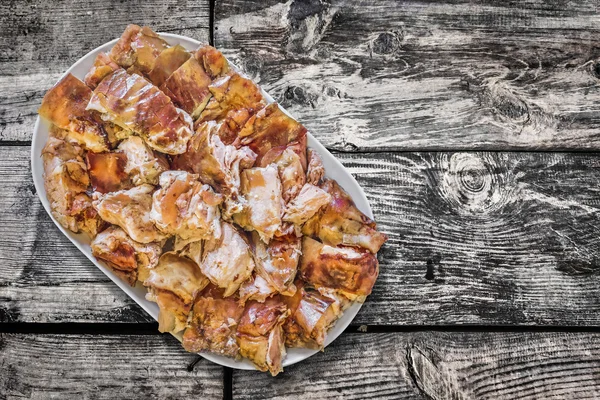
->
[[31, 32, 373, 370]]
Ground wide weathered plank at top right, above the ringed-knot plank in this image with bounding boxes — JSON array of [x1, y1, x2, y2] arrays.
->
[[214, 0, 600, 150]]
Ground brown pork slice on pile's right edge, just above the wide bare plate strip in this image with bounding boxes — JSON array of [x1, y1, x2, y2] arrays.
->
[[236, 103, 306, 170]]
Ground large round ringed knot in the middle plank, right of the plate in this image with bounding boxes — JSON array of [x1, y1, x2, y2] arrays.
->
[[437, 153, 513, 215]]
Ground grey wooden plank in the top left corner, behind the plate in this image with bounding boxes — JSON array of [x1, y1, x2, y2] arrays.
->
[[0, 0, 209, 141]]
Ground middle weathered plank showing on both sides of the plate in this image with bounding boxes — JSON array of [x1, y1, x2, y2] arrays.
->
[[5, 147, 600, 325]]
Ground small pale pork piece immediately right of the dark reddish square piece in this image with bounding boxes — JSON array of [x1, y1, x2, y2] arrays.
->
[[118, 136, 169, 186]]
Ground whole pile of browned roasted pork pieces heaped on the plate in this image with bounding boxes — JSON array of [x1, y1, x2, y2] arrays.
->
[[39, 25, 387, 375]]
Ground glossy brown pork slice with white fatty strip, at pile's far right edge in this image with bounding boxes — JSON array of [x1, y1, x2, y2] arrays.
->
[[300, 236, 379, 302]]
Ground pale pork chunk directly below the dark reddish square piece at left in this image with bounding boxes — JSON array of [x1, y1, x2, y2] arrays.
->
[[93, 184, 167, 243]]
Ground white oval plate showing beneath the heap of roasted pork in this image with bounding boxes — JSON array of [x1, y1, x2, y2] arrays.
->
[[31, 33, 373, 370]]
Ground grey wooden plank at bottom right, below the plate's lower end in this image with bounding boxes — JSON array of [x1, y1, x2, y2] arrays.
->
[[233, 332, 600, 400]]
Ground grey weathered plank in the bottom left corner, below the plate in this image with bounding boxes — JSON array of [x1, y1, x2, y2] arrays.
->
[[0, 334, 223, 399]]
